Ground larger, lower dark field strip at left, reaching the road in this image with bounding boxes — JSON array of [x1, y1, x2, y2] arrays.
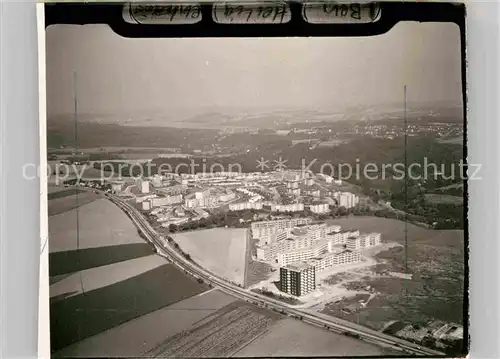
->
[[50, 264, 208, 352]]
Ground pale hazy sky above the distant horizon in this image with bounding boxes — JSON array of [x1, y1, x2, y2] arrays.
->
[[46, 22, 462, 116]]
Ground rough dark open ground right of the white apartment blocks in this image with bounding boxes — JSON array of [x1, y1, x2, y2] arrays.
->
[[325, 217, 465, 329]]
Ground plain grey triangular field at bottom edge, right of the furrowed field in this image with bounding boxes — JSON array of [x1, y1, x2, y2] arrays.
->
[[235, 318, 384, 357]]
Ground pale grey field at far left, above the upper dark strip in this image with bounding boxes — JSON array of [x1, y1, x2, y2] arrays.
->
[[49, 200, 145, 253]]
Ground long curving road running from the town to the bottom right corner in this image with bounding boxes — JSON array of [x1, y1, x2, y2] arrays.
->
[[105, 193, 445, 357]]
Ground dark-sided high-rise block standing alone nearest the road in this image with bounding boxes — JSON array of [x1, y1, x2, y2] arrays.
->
[[280, 263, 316, 297]]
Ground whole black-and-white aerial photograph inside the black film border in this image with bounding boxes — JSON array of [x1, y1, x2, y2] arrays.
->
[[46, 22, 467, 358]]
